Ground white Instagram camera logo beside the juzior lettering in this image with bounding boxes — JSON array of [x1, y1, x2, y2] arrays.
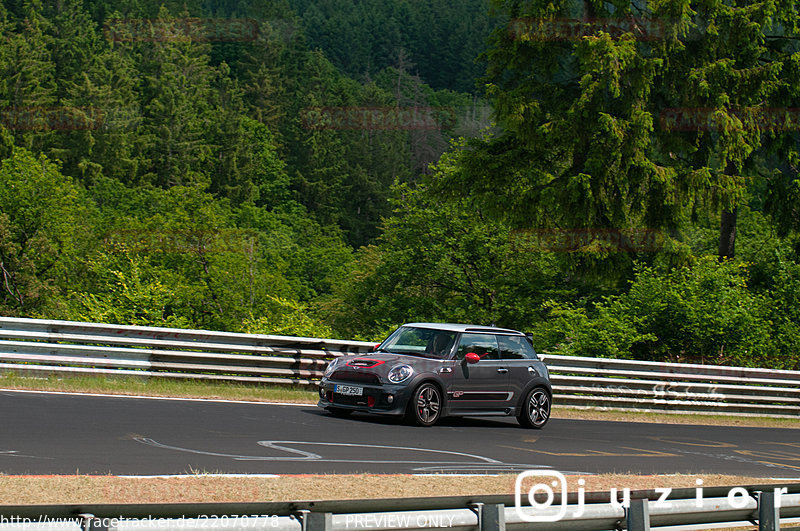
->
[[514, 470, 567, 522]]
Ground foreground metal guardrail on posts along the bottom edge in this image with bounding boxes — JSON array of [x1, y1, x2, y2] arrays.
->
[[0, 484, 800, 531]]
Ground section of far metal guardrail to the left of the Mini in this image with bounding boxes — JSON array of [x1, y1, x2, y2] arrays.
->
[[0, 317, 373, 385]]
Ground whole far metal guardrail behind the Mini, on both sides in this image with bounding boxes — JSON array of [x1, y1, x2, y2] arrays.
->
[[0, 317, 800, 418]]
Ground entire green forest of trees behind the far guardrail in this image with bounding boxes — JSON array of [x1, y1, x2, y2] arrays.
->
[[0, 0, 800, 369]]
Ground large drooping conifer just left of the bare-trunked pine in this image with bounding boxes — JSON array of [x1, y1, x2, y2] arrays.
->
[[440, 1, 668, 235]]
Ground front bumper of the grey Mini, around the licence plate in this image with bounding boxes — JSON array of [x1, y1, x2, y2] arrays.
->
[[317, 378, 412, 415]]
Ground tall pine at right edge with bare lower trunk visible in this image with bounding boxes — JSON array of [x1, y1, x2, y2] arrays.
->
[[658, 0, 800, 259]]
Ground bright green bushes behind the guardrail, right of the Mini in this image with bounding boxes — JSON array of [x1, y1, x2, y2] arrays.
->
[[534, 257, 800, 369]]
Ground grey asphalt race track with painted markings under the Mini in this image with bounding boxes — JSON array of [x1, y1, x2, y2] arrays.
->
[[0, 390, 800, 478]]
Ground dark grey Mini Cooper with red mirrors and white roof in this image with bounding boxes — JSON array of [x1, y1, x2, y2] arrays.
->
[[318, 323, 553, 428]]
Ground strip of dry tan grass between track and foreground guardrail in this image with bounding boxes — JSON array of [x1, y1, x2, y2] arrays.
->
[[0, 474, 796, 505]]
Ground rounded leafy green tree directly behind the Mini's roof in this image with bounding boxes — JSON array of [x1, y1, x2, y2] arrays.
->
[[324, 181, 574, 335]]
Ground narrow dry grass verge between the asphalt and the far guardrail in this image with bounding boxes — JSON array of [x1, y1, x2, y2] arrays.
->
[[0, 373, 800, 428]]
